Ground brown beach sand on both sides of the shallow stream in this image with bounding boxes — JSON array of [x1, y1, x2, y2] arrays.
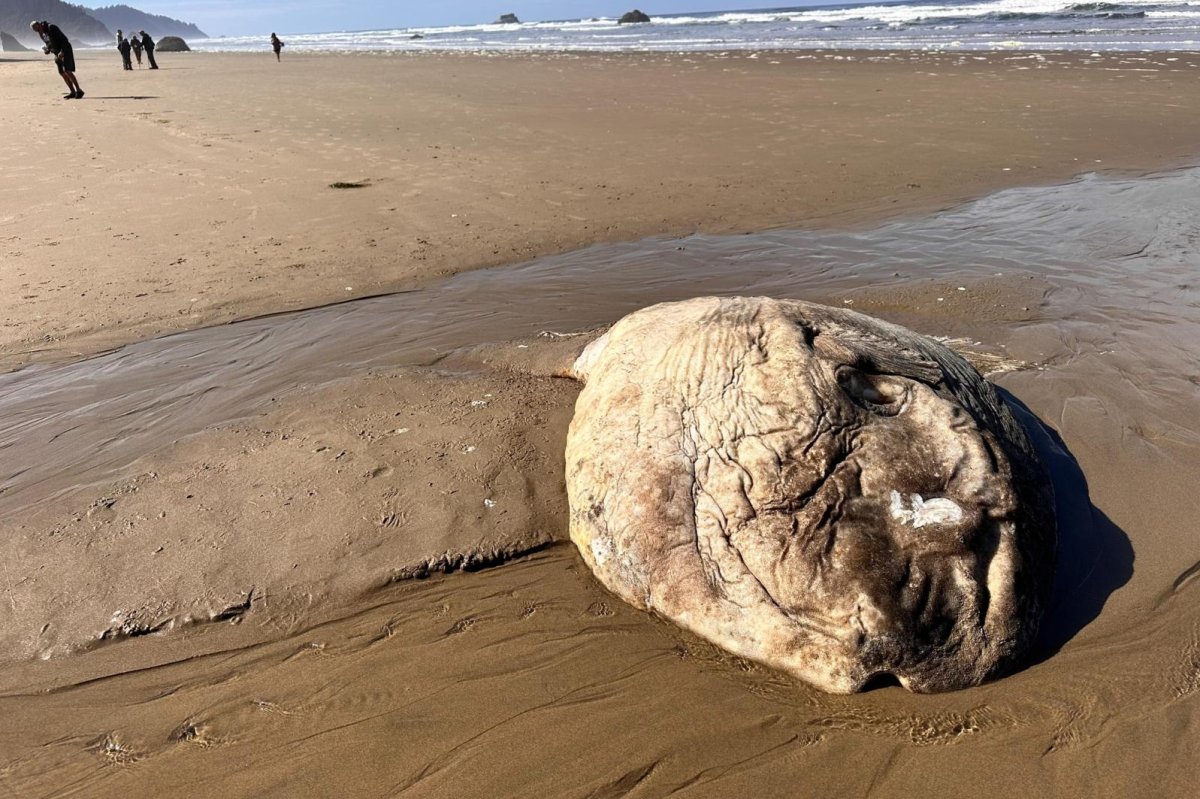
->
[[0, 53, 1200, 797]]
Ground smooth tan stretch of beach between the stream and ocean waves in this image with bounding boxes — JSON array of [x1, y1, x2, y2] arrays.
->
[[7, 50, 1200, 368]]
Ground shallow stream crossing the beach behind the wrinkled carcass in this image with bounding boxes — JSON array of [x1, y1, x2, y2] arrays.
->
[[0, 170, 1200, 519]]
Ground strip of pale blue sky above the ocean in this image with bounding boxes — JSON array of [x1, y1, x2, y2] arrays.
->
[[129, 0, 816, 36]]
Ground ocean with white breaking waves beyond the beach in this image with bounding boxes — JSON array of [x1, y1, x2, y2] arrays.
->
[[164, 0, 1200, 53]]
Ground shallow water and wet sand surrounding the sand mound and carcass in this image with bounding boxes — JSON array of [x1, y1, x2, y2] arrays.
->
[[0, 169, 1200, 797]]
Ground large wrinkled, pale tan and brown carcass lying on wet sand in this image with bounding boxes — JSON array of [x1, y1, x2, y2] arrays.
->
[[566, 298, 1055, 693]]
